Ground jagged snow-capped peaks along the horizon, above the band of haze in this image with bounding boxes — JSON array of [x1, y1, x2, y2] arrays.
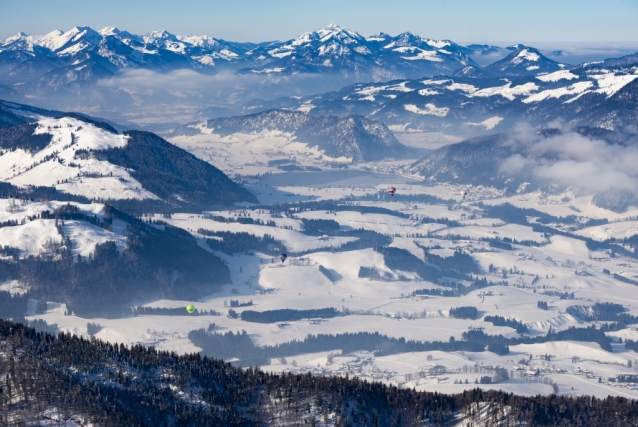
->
[[0, 24, 476, 78]]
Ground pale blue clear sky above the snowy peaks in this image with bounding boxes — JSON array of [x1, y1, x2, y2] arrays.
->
[[0, 0, 638, 44]]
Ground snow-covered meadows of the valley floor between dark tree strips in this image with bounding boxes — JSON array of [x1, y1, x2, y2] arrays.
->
[[17, 162, 638, 398]]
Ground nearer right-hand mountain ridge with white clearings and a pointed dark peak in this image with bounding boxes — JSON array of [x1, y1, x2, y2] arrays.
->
[[250, 52, 638, 133]]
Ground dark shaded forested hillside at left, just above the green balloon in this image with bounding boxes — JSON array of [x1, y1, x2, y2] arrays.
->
[[0, 205, 230, 317]]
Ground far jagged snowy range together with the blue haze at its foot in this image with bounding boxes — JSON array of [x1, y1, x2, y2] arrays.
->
[[0, 25, 502, 123]]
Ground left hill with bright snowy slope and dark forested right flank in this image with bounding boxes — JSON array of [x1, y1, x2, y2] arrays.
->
[[0, 114, 255, 209]]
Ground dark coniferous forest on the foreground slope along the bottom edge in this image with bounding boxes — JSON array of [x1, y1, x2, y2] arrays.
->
[[0, 321, 638, 427]]
